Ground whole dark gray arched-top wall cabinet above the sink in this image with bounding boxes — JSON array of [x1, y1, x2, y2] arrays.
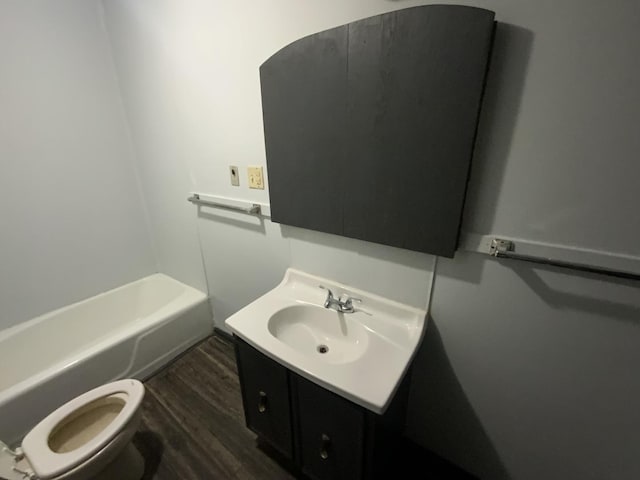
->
[[260, 5, 494, 256]]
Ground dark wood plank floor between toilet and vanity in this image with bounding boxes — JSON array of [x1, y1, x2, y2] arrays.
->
[[133, 335, 294, 480]]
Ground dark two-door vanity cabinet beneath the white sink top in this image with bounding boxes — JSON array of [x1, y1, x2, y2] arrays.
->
[[234, 337, 408, 480]]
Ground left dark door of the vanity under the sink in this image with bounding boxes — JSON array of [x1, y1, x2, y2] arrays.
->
[[236, 337, 293, 458]]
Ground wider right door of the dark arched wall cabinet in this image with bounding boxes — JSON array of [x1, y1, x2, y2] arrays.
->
[[344, 5, 493, 256]]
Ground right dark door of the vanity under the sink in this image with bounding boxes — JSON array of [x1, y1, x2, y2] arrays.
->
[[294, 375, 365, 480]]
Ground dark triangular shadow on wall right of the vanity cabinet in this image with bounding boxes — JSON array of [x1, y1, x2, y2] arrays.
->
[[407, 318, 511, 480]]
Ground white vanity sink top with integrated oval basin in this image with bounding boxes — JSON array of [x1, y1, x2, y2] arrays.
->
[[226, 269, 426, 413]]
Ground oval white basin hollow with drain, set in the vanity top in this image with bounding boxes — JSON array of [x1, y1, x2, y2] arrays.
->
[[268, 305, 369, 363]]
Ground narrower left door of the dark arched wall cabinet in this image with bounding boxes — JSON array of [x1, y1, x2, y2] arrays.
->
[[260, 26, 348, 234]]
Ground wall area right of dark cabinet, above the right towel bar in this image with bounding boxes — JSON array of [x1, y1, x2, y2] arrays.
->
[[465, 0, 640, 260]]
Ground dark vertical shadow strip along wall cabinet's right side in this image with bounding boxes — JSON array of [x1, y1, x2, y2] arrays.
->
[[462, 22, 534, 240]]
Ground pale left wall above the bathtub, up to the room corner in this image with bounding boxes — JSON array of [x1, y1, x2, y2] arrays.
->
[[0, 0, 155, 329]]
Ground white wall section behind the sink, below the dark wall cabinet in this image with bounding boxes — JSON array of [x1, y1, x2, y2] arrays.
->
[[200, 218, 434, 322]]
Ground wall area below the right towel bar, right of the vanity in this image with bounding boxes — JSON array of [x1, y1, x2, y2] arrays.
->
[[408, 253, 640, 480]]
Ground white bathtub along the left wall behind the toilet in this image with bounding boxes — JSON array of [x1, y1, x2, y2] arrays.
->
[[0, 274, 213, 444]]
